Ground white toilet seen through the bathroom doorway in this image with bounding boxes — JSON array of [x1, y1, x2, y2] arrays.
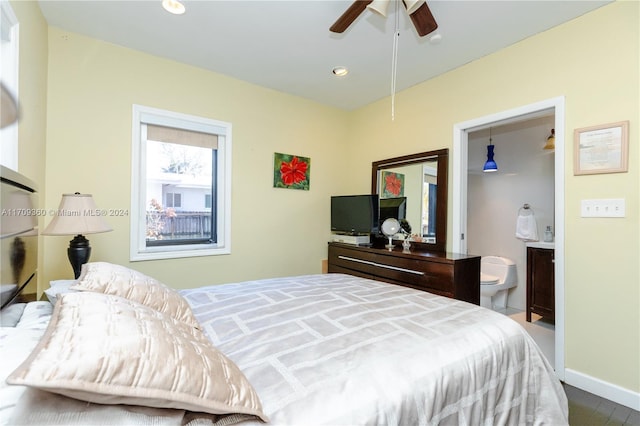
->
[[480, 256, 518, 309]]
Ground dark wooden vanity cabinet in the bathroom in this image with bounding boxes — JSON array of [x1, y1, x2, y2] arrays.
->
[[526, 247, 555, 322]]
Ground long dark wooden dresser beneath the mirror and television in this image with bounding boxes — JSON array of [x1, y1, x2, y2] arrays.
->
[[328, 242, 480, 305]]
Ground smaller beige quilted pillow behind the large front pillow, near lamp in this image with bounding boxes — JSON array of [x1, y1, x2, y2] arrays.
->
[[70, 262, 200, 328]]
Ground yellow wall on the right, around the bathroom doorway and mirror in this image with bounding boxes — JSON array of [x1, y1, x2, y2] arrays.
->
[[350, 2, 640, 392]]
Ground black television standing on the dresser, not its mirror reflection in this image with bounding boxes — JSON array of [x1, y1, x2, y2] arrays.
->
[[331, 194, 380, 235]]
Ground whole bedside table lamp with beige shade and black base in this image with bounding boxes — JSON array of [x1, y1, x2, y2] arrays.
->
[[42, 192, 113, 278]]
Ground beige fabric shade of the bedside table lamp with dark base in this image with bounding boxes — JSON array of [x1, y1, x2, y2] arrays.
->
[[42, 192, 113, 235]]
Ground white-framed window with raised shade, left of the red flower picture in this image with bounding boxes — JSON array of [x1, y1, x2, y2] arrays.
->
[[130, 105, 231, 261]]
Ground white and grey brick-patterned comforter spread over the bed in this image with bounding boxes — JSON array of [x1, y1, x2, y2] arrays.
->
[[182, 274, 568, 425]]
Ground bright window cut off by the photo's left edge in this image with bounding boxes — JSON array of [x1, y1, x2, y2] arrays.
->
[[0, 0, 19, 170]]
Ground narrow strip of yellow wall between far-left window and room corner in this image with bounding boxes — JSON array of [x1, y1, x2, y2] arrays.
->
[[10, 2, 48, 293]]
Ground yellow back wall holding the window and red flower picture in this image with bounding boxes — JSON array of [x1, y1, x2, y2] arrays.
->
[[42, 28, 347, 288]]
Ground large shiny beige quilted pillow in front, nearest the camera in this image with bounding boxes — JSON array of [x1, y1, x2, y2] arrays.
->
[[7, 292, 267, 421]]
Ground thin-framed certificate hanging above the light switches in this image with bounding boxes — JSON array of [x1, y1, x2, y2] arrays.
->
[[573, 121, 629, 175]]
